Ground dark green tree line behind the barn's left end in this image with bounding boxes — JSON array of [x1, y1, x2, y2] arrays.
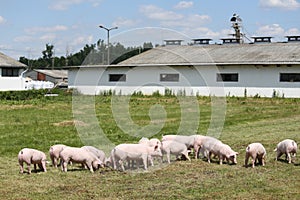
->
[[19, 40, 153, 69]]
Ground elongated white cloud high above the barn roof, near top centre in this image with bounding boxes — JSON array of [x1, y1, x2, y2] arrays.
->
[[140, 5, 183, 20]]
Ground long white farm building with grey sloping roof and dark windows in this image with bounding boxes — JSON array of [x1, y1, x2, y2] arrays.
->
[[68, 36, 300, 98]]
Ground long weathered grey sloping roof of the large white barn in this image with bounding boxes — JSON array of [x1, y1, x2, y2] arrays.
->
[[118, 42, 300, 66]]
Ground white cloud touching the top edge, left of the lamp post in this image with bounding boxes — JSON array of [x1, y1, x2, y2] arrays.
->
[[49, 0, 102, 11]]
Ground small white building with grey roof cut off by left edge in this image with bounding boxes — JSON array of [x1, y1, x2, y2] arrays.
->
[[0, 50, 27, 91]]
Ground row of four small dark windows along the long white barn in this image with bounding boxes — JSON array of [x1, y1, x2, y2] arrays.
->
[[109, 73, 300, 82]]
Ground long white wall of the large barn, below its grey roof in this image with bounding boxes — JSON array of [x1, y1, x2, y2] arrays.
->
[[68, 65, 300, 97]]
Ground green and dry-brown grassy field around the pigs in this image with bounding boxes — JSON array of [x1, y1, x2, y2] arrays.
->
[[0, 95, 300, 199]]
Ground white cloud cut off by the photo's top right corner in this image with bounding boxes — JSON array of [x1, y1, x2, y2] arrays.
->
[[259, 0, 300, 10]]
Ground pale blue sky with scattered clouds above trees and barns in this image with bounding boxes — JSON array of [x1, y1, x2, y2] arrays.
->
[[0, 0, 300, 60]]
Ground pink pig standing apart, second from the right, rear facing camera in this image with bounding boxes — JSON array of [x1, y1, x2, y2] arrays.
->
[[245, 143, 267, 168]]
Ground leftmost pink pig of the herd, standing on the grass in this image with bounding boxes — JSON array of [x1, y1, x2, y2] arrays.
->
[[18, 148, 47, 174]]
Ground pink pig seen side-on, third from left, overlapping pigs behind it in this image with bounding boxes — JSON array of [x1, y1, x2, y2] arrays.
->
[[59, 147, 103, 173]]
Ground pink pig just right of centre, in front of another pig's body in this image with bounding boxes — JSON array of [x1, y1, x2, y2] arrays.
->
[[161, 140, 191, 163]]
